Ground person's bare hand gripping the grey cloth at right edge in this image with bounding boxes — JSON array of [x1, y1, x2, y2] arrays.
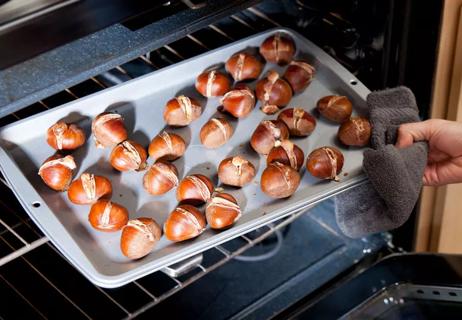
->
[[396, 119, 462, 186]]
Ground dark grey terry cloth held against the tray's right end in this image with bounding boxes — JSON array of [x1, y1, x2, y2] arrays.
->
[[335, 87, 428, 238]]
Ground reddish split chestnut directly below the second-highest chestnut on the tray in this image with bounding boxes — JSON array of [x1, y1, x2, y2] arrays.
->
[[221, 85, 255, 118]]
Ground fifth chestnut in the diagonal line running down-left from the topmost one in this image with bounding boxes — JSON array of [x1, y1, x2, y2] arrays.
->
[[148, 131, 186, 161]]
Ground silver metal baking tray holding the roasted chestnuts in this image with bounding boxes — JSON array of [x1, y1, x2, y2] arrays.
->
[[0, 28, 369, 288]]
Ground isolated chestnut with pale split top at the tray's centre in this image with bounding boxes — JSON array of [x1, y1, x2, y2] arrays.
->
[[218, 156, 256, 187]]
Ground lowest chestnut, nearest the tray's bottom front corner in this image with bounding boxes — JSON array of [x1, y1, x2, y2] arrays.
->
[[120, 217, 162, 259]]
